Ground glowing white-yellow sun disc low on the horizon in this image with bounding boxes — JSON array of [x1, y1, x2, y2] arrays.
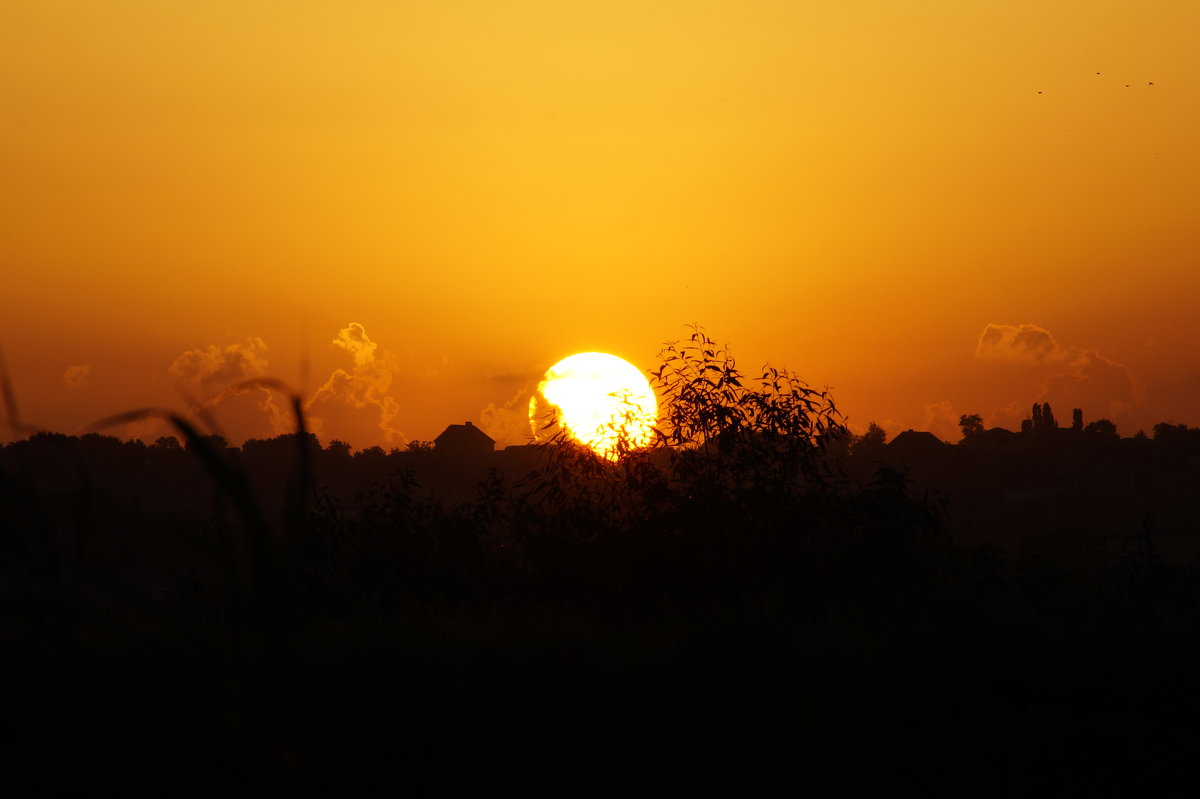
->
[[529, 353, 658, 459]]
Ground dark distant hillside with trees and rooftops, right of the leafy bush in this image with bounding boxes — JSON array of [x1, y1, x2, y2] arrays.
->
[[846, 403, 1200, 559]]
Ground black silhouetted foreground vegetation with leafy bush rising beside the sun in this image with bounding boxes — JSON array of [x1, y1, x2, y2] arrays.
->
[[0, 334, 1200, 795]]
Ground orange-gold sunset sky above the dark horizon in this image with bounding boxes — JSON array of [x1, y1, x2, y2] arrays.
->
[[0, 0, 1200, 446]]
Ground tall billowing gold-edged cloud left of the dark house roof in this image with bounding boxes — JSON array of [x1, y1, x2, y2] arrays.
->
[[305, 322, 408, 444]]
